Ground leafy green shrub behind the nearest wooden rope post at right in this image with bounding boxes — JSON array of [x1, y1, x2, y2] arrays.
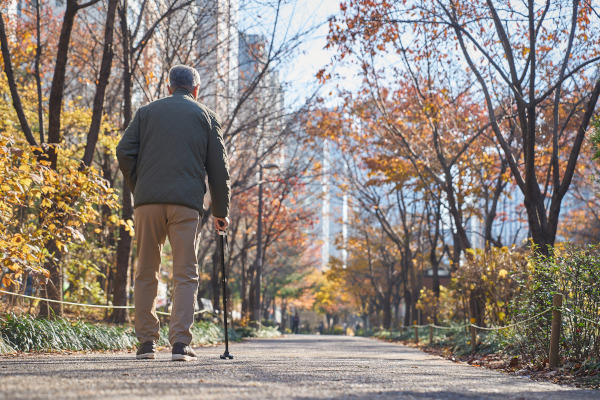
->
[[512, 244, 600, 361]]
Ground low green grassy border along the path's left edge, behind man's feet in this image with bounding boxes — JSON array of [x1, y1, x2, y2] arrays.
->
[[0, 314, 279, 354]]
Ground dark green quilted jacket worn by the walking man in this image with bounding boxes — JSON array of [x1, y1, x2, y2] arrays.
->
[[117, 88, 231, 218]]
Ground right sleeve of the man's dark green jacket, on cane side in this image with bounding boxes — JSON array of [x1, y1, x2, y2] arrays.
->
[[206, 116, 231, 218]]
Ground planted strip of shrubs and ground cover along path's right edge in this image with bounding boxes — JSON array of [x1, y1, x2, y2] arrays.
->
[[372, 244, 600, 388]]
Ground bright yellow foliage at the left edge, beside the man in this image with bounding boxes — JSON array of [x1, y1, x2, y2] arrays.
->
[[0, 133, 120, 285]]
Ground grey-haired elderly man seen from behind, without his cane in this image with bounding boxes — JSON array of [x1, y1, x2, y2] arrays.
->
[[117, 65, 231, 361]]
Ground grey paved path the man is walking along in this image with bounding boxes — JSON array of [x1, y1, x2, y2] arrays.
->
[[0, 335, 600, 400]]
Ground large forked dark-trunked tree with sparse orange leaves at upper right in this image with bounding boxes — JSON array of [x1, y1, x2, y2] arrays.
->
[[330, 0, 600, 254]]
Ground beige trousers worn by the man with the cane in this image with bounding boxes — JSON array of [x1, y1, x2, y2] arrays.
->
[[134, 204, 200, 345]]
